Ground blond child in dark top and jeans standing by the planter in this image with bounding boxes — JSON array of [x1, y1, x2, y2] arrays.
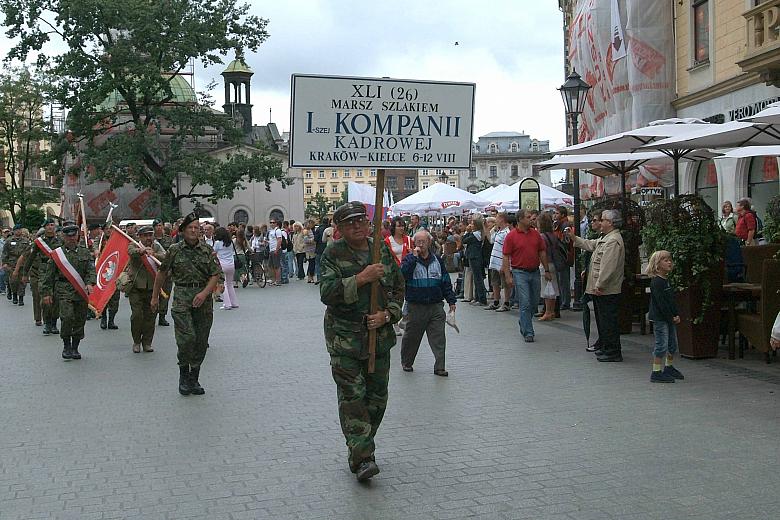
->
[[647, 250, 685, 383]]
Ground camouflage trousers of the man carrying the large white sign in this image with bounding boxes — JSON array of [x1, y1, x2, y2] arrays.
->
[[330, 352, 390, 473]]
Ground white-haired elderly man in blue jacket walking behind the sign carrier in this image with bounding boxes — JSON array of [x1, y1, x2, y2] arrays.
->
[[401, 230, 456, 377]]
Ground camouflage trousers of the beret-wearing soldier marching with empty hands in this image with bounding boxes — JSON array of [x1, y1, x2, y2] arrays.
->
[[171, 287, 214, 367]]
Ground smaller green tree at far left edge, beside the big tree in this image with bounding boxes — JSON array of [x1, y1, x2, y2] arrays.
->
[[0, 69, 58, 224]]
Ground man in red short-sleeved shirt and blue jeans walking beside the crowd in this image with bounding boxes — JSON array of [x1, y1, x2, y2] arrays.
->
[[501, 209, 552, 343]]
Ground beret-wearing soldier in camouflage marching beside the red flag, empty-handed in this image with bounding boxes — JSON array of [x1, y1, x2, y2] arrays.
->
[[151, 213, 222, 395]]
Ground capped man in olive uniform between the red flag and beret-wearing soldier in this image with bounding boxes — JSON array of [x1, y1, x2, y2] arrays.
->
[[127, 226, 165, 353]]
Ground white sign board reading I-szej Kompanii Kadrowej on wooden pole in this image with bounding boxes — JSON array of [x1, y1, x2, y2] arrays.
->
[[290, 74, 475, 169]]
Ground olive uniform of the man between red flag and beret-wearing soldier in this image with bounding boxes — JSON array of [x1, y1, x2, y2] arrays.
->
[[128, 242, 165, 347]]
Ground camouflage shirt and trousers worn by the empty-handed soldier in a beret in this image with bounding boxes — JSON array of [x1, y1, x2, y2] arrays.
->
[[160, 240, 222, 367]]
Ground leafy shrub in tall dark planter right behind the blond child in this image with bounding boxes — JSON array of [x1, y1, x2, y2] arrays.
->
[[642, 195, 724, 358]]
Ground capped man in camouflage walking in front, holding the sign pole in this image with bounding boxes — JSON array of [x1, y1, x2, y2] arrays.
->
[[320, 202, 404, 482]]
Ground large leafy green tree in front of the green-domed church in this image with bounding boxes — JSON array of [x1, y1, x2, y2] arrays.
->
[[0, 0, 290, 216]]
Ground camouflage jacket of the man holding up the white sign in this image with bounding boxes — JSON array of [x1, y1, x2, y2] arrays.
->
[[320, 239, 405, 359]]
